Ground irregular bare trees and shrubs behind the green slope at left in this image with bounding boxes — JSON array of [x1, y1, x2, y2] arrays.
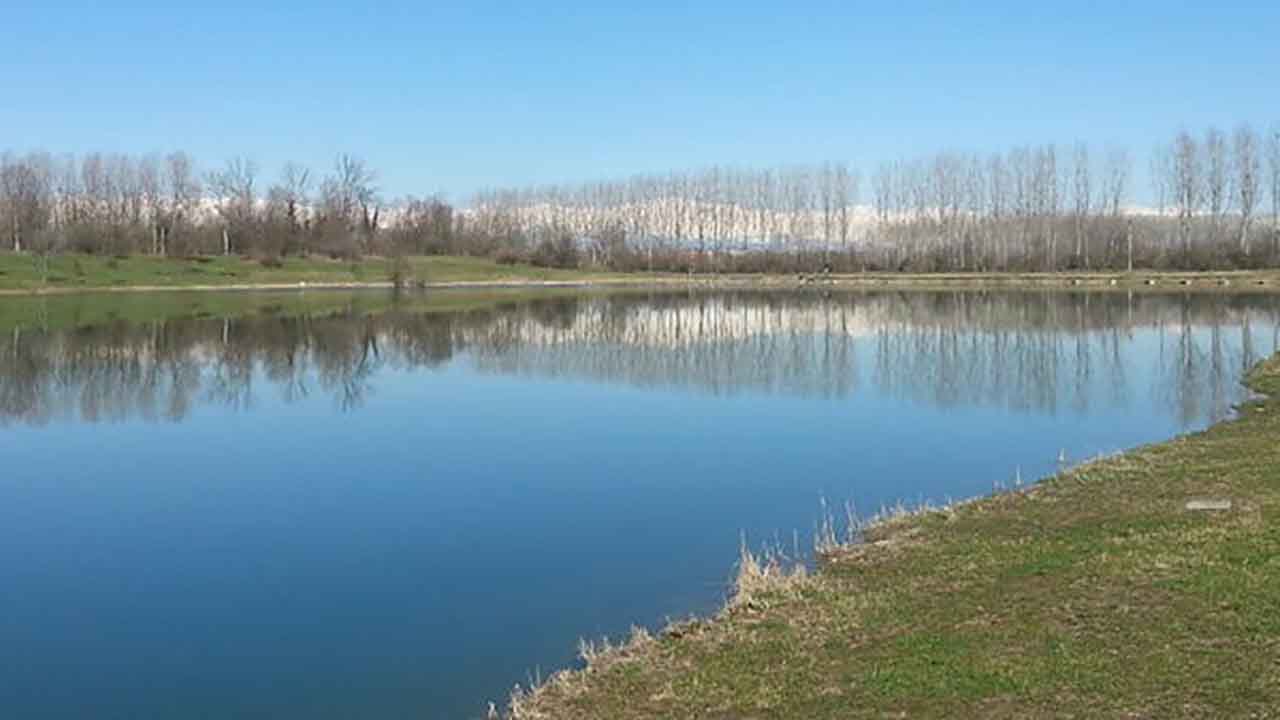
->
[[0, 151, 460, 259]]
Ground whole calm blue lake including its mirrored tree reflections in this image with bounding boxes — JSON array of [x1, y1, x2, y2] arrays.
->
[[0, 288, 1280, 719]]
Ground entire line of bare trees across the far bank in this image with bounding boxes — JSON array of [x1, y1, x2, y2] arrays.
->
[[0, 124, 1280, 272]]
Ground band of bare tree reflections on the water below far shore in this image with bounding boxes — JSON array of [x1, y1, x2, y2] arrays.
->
[[0, 291, 1280, 425]]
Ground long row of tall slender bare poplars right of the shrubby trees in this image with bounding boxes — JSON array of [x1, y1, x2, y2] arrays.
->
[[472, 124, 1280, 272]]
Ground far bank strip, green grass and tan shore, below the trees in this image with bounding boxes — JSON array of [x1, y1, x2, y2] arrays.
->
[[0, 254, 1280, 295]]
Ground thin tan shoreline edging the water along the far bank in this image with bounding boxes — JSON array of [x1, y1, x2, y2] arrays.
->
[[0, 270, 1280, 297]]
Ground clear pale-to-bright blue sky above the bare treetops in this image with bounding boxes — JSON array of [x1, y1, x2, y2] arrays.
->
[[0, 0, 1280, 201]]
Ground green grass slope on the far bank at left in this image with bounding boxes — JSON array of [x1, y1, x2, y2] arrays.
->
[[0, 254, 614, 291]]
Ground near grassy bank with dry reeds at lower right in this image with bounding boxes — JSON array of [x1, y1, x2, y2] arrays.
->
[[515, 359, 1280, 720]]
